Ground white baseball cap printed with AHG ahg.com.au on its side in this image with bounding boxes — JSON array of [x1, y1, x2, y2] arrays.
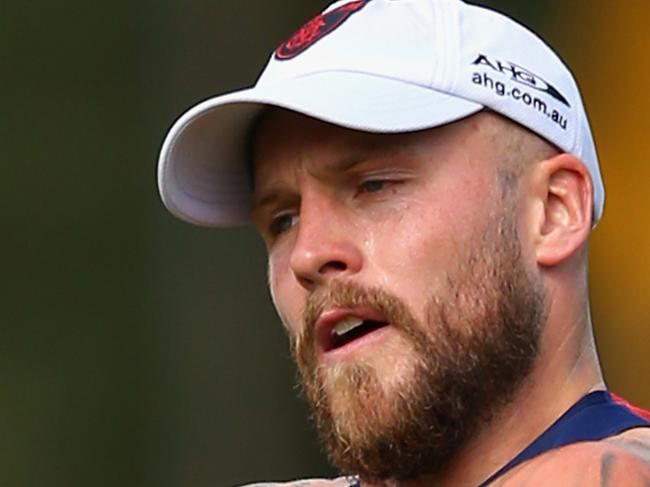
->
[[158, 0, 605, 227]]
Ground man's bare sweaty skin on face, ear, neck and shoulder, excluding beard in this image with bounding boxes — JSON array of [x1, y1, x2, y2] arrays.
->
[[248, 110, 650, 487]]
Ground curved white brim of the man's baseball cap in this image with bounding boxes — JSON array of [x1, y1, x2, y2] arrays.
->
[[158, 72, 483, 227]]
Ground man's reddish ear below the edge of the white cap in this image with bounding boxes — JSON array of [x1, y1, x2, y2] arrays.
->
[[534, 154, 594, 266]]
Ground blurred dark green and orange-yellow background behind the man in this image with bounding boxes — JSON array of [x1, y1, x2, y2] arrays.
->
[[0, 0, 650, 487]]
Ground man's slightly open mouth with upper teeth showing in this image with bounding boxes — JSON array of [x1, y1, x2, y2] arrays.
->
[[316, 310, 389, 353]]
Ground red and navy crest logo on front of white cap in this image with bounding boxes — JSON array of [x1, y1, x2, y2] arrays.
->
[[275, 0, 370, 61]]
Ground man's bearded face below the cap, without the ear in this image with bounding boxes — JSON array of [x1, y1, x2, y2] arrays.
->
[[254, 110, 543, 480]]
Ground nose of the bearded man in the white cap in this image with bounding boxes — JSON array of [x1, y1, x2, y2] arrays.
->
[[289, 198, 363, 291]]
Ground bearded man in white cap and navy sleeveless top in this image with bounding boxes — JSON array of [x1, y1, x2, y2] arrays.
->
[[159, 0, 650, 486]]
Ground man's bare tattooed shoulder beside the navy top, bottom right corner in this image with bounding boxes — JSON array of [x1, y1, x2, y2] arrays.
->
[[497, 428, 650, 487]]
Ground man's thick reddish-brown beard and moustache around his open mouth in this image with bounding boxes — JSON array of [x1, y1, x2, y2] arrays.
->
[[292, 210, 546, 482]]
